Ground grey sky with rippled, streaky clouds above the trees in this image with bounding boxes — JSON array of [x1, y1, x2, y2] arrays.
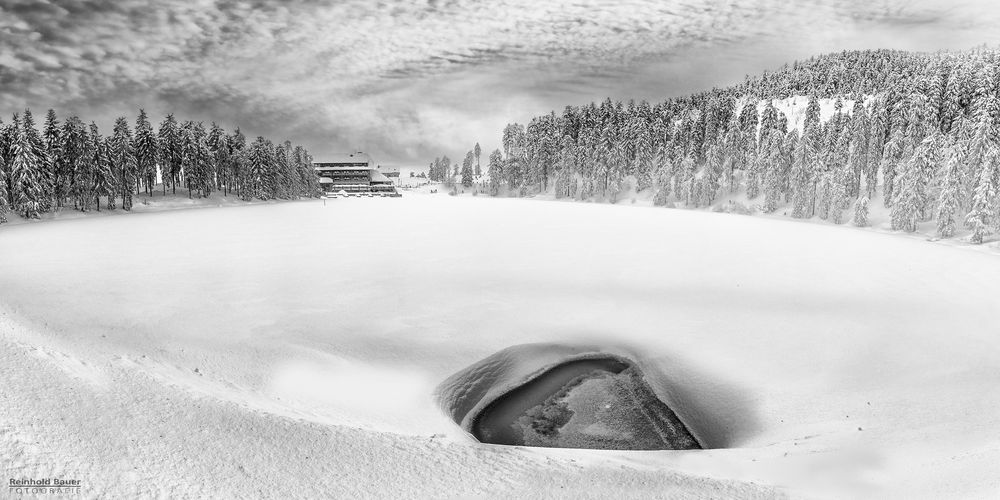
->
[[0, 0, 1000, 166]]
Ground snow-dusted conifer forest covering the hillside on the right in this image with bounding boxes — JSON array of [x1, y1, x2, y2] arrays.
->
[[440, 48, 1000, 243]]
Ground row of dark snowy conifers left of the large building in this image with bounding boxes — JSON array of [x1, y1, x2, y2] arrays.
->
[[0, 109, 319, 222]]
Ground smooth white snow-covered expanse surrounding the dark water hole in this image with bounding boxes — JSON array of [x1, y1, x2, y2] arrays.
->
[[0, 194, 1000, 498]]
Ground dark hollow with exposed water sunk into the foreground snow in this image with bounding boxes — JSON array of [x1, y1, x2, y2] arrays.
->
[[437, 344, 702, 450]]
